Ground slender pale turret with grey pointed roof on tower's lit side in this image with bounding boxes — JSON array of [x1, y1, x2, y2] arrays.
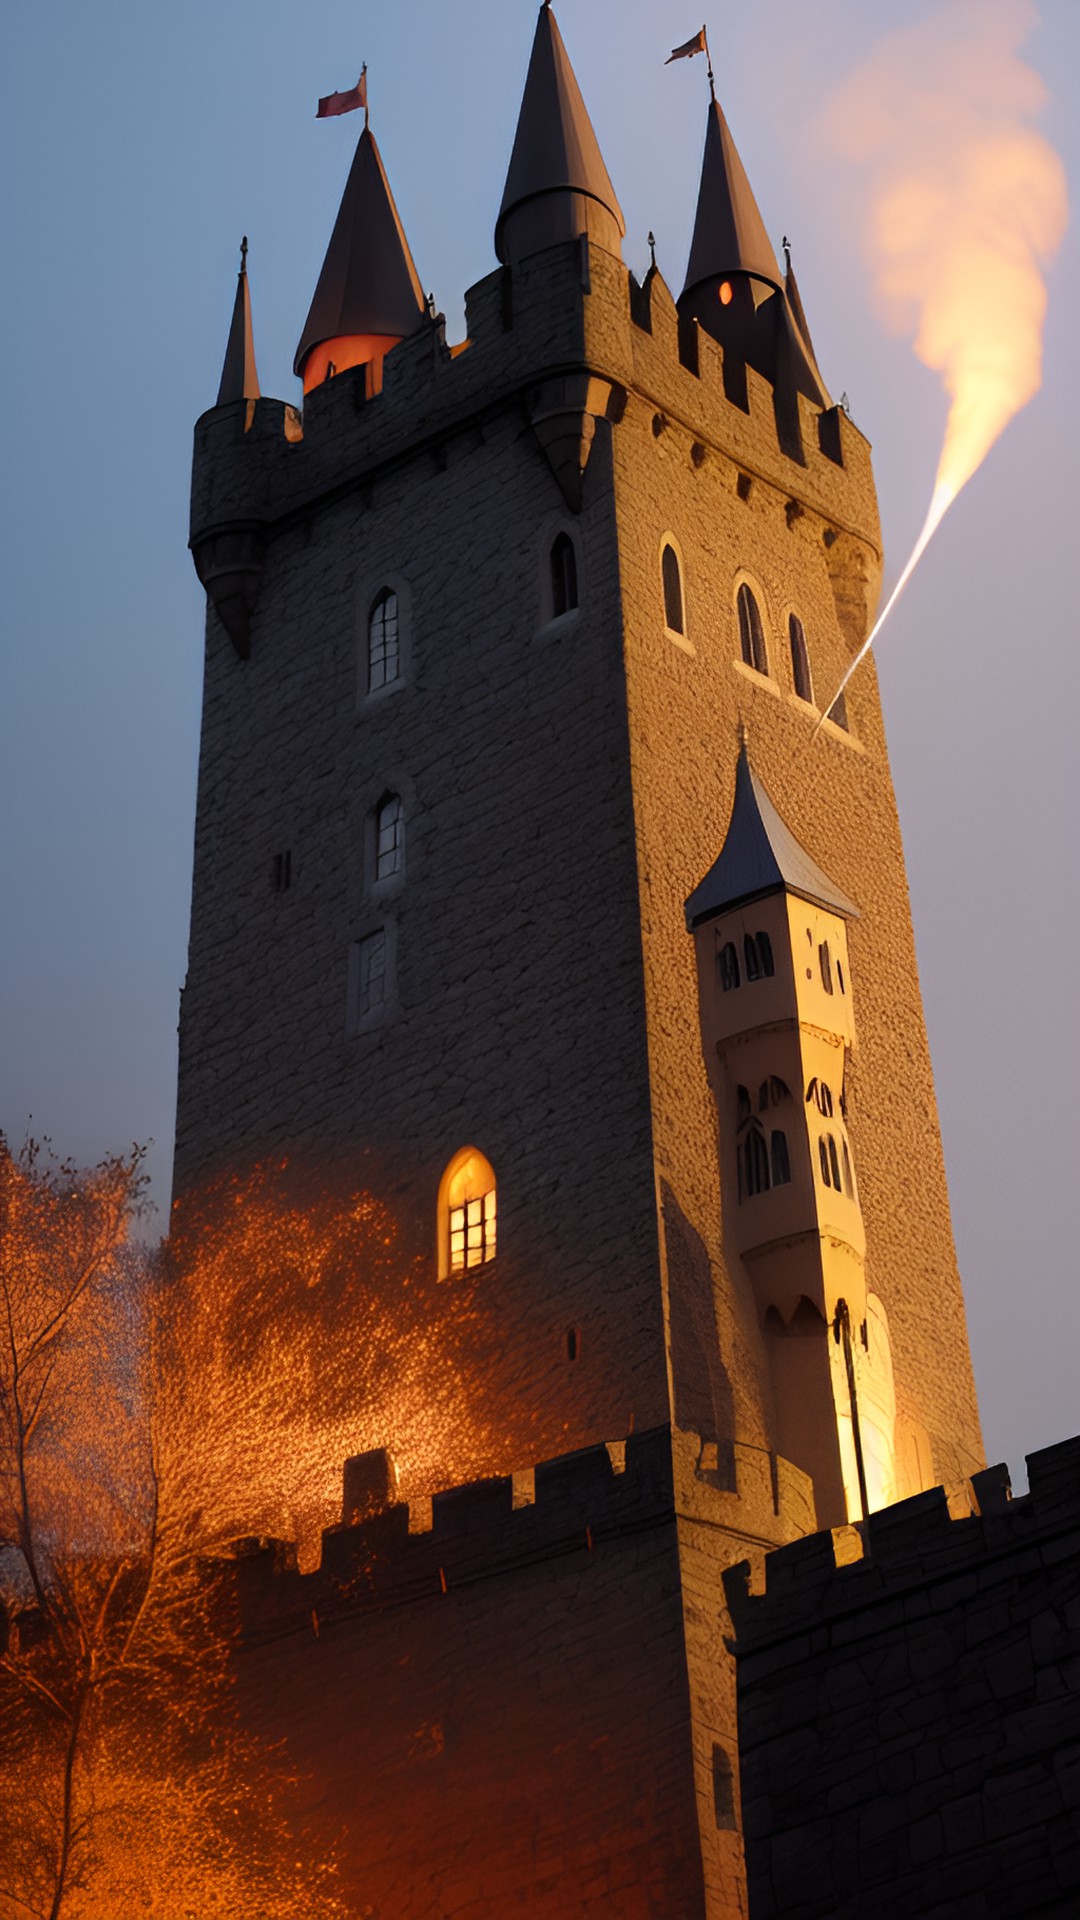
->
[[686, 747, 897, 1526]]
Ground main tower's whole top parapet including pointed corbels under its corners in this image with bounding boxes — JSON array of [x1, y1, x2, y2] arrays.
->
[[190, 238, 880, 653]]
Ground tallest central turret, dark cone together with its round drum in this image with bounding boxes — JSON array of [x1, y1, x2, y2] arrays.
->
[[496, 0, 626, 265]]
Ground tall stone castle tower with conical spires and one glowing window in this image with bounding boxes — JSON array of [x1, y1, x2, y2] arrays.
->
[[175, 6, 980, 1916]]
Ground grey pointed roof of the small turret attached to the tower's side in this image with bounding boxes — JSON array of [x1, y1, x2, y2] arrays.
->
[[686, 747, 859, 931]]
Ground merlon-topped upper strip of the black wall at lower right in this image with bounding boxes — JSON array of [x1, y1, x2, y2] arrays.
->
[[724, 1436, 1080, 1665]]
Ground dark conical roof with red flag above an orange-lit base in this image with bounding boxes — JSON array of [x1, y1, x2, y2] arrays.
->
[[292, 127, 425, 372]]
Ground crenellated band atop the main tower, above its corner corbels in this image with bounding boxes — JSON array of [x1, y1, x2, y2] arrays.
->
[[190, 242, 880, 591]]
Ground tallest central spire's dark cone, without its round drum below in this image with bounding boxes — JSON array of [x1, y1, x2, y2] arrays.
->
[[496, 6, 626, 259]]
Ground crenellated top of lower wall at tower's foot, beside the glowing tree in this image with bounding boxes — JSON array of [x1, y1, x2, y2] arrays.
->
[[234, 1427, 811, 1642]]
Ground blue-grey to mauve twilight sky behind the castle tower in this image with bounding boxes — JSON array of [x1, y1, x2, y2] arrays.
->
[[0, 0, 1080, 1484]]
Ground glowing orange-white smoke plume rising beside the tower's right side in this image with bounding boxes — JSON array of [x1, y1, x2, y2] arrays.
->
[[822, 0, 1067, 714]]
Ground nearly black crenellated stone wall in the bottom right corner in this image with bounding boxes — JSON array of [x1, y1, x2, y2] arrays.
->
[[724, 1438, 1080, 1920]]
